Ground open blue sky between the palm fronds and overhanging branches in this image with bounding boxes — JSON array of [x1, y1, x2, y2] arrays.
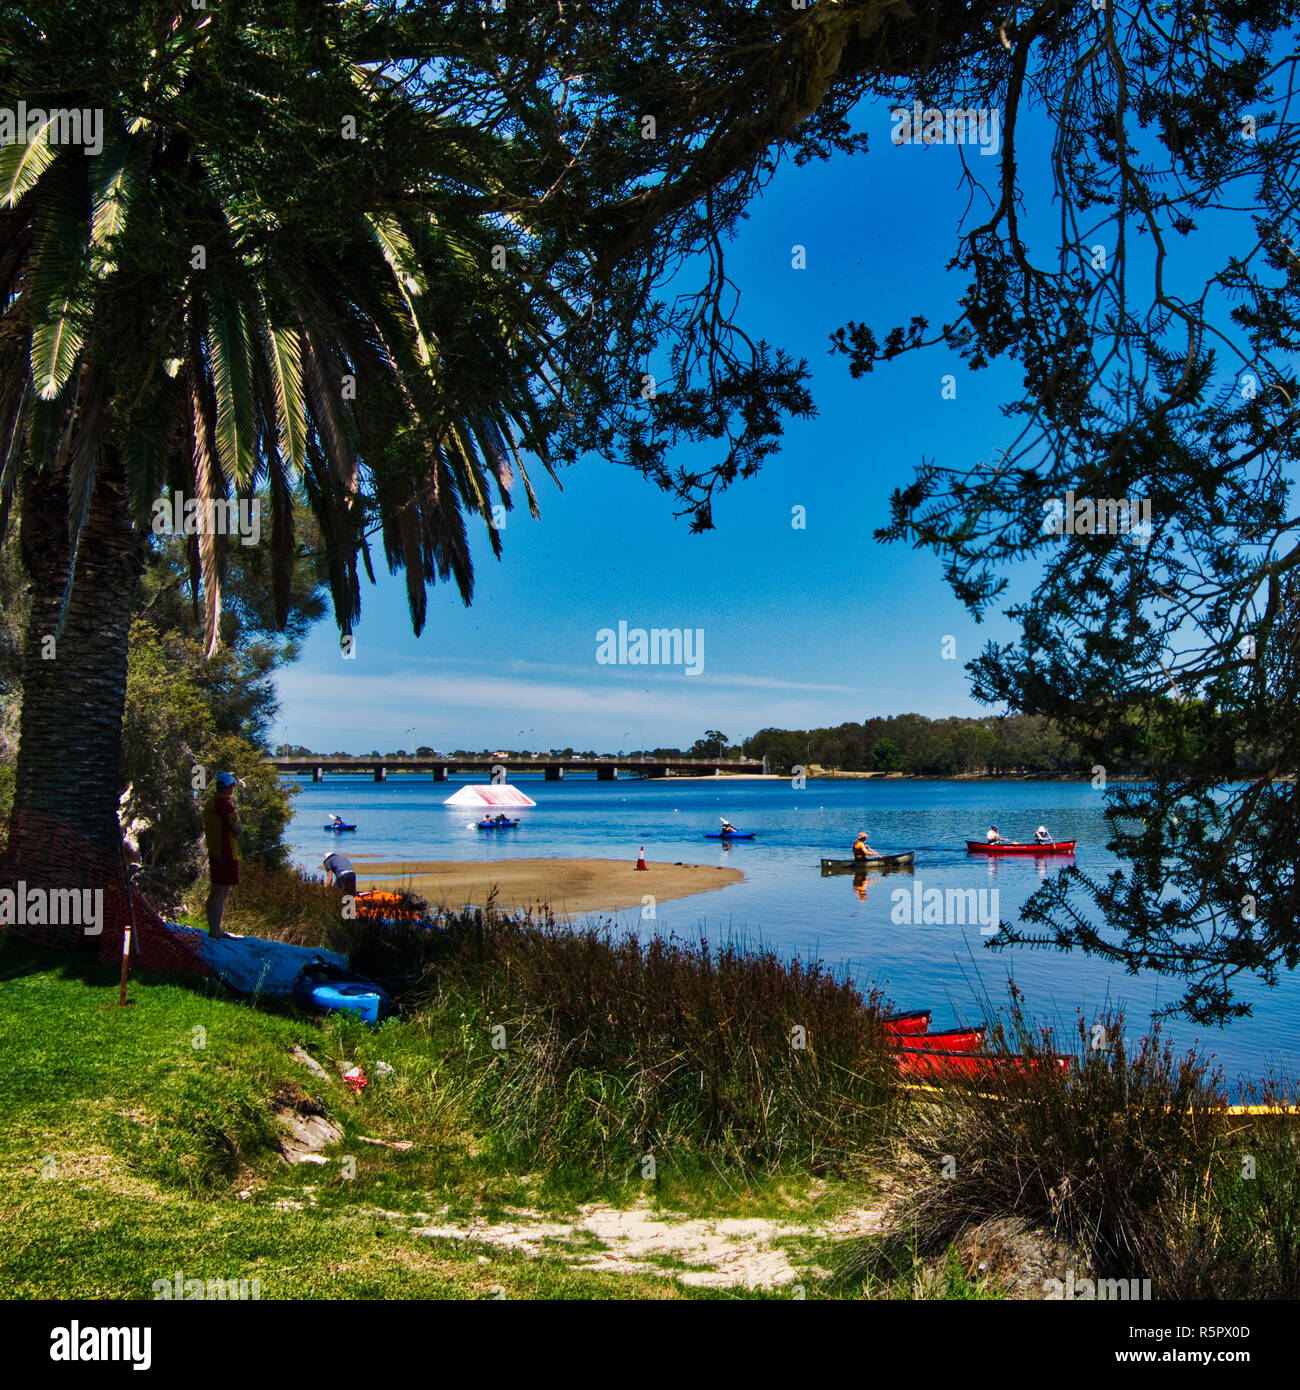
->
[[274, 103, 1040, 752]]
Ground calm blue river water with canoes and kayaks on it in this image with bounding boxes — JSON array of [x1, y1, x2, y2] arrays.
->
[[289, 776, 1300, 1077]]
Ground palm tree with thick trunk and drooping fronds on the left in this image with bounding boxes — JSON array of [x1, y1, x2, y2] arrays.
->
[[0, 11, 567, 877]]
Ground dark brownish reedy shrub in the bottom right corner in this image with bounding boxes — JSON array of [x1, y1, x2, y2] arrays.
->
[[840, 1001, 1300, 1298]]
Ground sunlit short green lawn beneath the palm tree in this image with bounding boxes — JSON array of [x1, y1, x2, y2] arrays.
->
[[0, 940, 878, 1298]]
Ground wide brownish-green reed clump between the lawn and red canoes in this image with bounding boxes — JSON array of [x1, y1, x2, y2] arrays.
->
[[335, 910, 901, 1173]]
